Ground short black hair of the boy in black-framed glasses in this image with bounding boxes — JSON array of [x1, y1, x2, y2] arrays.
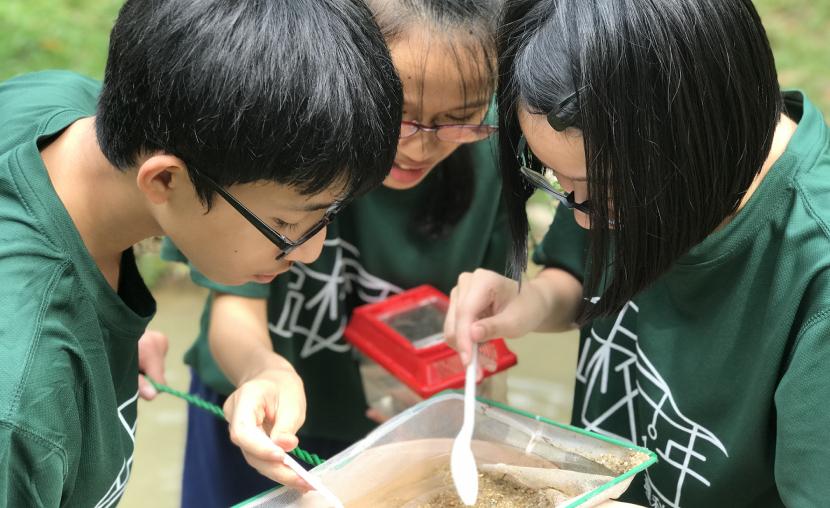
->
[[96, 0, 402, 206]]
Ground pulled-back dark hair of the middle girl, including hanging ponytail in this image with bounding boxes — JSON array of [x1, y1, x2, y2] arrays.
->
[[368, 0, 503, 240]]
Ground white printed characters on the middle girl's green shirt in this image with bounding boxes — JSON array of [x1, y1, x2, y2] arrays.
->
[[268, 238, 401, 358]]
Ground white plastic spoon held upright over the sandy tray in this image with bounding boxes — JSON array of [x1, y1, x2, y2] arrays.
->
[[450, 344, 478, 506]]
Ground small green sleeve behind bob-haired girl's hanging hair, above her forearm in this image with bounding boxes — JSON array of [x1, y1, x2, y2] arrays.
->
[[533, 206, 588, 282]]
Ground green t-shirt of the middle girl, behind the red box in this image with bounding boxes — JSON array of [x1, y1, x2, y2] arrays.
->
[[164, 140, 508, 441]]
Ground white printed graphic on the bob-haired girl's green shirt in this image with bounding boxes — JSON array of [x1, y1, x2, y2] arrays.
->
[[576, 302, 729, 508]]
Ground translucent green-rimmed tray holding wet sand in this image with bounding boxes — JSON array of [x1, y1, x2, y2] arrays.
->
[[237, 392, 657, 508]]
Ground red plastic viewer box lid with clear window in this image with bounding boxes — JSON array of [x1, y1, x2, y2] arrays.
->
[[344, 285, 516, 398]]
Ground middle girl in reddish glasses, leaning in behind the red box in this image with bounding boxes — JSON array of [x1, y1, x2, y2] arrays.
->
[[167, 0, 509, 507]]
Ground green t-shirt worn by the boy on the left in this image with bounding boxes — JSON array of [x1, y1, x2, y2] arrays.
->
[[0, 72, 155, 507]]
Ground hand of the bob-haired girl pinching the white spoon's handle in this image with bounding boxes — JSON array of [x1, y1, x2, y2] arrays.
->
[[444, 269, 544, 365]]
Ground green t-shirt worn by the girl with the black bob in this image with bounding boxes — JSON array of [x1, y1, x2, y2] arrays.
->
[[534, 92, 830, 507]]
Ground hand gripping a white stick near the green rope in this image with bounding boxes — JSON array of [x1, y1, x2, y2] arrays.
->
[[224, 368, 311, 491]]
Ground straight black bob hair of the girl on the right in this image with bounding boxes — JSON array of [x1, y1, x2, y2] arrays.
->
[[499, 0, 782, 322]]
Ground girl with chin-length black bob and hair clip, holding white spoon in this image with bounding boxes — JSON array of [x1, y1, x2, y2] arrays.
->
[[445, 0, 830, 507]]
